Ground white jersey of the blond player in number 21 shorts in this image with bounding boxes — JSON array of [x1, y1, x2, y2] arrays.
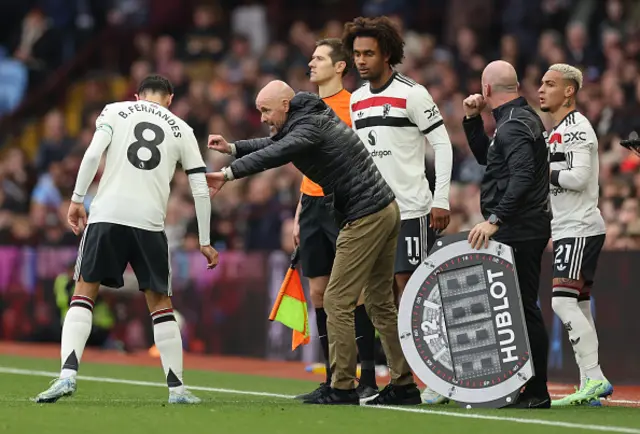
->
[[547, 111, 606, 240]]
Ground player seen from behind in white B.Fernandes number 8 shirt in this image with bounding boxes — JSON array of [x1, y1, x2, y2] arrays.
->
[[35, 75, 218, 404]]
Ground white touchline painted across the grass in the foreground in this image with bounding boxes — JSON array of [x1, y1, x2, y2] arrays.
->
[[0, 366, 640, 434]]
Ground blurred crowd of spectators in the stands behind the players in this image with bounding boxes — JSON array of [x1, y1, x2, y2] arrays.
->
[[0, 0, 640, 250]]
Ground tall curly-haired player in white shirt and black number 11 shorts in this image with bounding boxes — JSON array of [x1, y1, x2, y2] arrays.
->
[[343, 17, 453, 404]]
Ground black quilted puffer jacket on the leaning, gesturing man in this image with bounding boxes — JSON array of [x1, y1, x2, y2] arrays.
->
[[230, 92, 395, 226]]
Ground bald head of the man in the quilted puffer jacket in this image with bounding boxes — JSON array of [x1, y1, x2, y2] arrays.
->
[[256, 80, 296, 136]]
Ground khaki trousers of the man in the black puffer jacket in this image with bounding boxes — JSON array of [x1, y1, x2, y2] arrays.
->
[[324, 201, 414, 390]]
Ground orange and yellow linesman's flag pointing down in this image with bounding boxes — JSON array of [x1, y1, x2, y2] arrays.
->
[[269, 247, 310, 351]]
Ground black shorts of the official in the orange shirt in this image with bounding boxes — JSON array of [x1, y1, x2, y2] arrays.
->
[[299, 194, 340, 278]]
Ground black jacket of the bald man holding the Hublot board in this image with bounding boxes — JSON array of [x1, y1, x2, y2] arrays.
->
[[463, 97, 552, 243]]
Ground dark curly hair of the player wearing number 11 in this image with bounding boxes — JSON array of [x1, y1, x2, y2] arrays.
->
[[342, 16, 404, 66]]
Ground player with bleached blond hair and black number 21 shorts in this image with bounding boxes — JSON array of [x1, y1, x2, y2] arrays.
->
[[539, 64, 613, 406]]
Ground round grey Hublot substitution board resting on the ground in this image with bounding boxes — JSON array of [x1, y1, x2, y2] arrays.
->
[[398, 232, 534, 408]]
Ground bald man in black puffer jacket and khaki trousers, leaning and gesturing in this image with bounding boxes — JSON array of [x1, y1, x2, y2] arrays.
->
[[207, 81, 420, 405]]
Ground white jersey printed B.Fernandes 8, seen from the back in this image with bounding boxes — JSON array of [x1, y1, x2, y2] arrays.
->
[[88, 101, 205, 231]]
